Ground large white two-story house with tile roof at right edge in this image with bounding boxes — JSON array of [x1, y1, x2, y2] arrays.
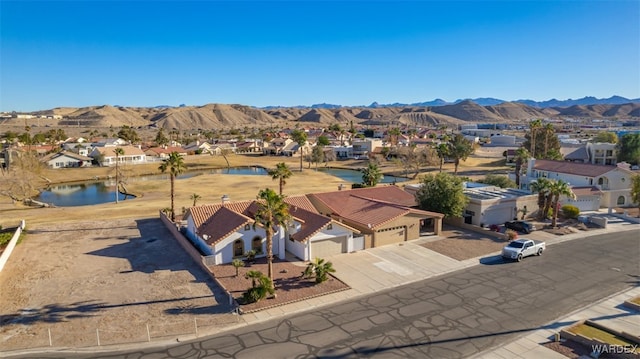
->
[[521, 158, 633, 210]]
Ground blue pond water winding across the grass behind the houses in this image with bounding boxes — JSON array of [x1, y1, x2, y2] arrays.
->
[[35, 166, 406, 207]]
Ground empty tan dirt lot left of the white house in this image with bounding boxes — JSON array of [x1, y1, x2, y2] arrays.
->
[[0, 219, 237, 351]]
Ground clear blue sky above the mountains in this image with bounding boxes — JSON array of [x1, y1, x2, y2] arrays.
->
[[0, 0, 640, 111]]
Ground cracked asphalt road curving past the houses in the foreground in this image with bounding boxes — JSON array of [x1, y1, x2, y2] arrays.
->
[[10, 232, 640, 359]]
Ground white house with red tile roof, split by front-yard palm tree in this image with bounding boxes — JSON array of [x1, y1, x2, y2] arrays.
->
[[185, 196, 363, 264]]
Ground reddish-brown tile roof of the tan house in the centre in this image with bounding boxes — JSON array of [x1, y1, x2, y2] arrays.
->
[[308, 186, 444, 228]]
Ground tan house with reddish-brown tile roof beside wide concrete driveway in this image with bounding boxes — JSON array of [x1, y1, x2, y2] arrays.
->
[[307, 186, 444, 249]]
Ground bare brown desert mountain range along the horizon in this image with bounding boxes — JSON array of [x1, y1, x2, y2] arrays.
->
[[0, 96, 640, 130]]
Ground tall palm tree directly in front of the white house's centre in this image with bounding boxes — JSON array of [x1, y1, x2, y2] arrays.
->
[[254, 188, 291, 282]]
